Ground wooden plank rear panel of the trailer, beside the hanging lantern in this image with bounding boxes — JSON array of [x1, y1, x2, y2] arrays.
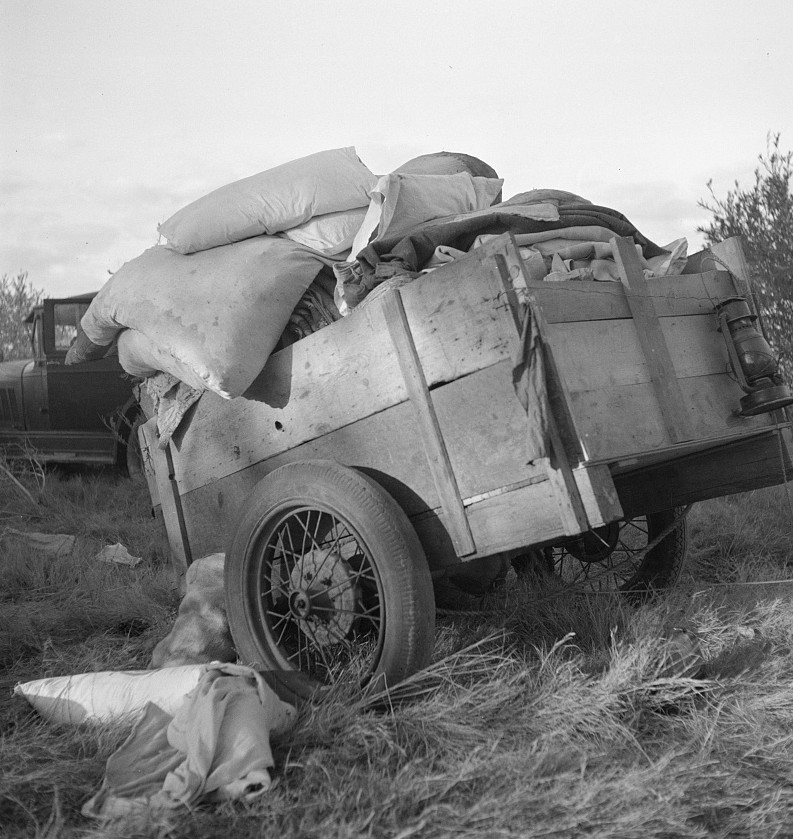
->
[[528, 253, 775, 470]]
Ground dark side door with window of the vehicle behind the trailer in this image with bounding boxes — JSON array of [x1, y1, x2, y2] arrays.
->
[[44, 300, 132, 431]]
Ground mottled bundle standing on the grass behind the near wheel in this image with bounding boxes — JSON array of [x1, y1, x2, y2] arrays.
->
[[151, 553, 237, 667]]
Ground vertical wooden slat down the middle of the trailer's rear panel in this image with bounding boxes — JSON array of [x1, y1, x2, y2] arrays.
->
[[603, 236, 693, 443]]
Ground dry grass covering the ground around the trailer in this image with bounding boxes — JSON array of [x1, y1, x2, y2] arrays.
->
[[0, 466, 793, 839]]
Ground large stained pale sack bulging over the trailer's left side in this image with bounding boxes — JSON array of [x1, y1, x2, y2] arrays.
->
[[81, 236, 332, 399]]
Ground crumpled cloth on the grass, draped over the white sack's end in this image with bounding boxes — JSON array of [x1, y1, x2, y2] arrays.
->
[[82, 664, 297, 828]]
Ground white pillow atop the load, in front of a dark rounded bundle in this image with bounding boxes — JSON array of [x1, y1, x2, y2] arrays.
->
[[352, 172, 504, 256]]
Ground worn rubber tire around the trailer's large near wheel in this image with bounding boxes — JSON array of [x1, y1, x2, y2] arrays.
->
[[225, 460, 435, 701]]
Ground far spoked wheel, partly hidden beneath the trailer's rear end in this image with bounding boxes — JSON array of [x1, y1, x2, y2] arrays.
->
[[547, 510, 687, 599]]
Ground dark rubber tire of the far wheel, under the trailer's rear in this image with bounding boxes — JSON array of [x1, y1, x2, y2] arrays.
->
[[556, 508, 688, 603]]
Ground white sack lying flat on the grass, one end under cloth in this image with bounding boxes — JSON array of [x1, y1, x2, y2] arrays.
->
[[14, 664, 207, 725]]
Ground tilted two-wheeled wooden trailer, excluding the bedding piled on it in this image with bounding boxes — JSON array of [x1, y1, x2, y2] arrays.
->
[[141, 234, 793, 697]]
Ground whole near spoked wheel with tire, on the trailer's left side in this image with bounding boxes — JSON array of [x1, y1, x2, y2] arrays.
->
[[225, 460, 435, 700]]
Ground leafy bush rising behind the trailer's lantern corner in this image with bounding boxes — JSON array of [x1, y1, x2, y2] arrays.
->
[[697, 134, 793, 383]]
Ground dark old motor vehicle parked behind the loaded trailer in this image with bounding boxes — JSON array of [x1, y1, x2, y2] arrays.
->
[[0, 292, 140, 473]]
